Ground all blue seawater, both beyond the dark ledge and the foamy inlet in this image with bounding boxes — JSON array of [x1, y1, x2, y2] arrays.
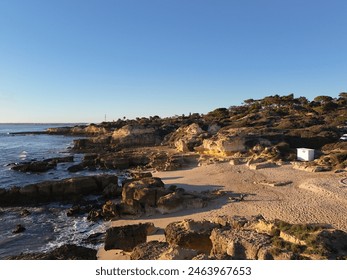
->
[[0, 124, 107, 259]]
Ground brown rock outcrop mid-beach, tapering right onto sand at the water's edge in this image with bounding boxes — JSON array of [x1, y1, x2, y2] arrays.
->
[[88, 173, 213, 221]]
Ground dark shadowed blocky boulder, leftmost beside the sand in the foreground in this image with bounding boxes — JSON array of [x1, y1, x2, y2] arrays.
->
[[104, 224, 148, 252]]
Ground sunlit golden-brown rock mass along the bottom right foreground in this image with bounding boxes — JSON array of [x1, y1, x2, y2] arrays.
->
[[128, 216, 347, 260]]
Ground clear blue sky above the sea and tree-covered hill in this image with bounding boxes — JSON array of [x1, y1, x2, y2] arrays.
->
[[0, 0, 347, 122]]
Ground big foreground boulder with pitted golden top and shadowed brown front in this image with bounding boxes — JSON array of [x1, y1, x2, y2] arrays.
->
[[165, 220, 219, 254]]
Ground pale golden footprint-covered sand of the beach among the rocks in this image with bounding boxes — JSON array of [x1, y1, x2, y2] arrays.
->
[[98, 163, 347, 260]]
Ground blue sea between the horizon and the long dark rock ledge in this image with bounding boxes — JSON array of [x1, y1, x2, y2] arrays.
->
[[0, 124, 78, 188]]
